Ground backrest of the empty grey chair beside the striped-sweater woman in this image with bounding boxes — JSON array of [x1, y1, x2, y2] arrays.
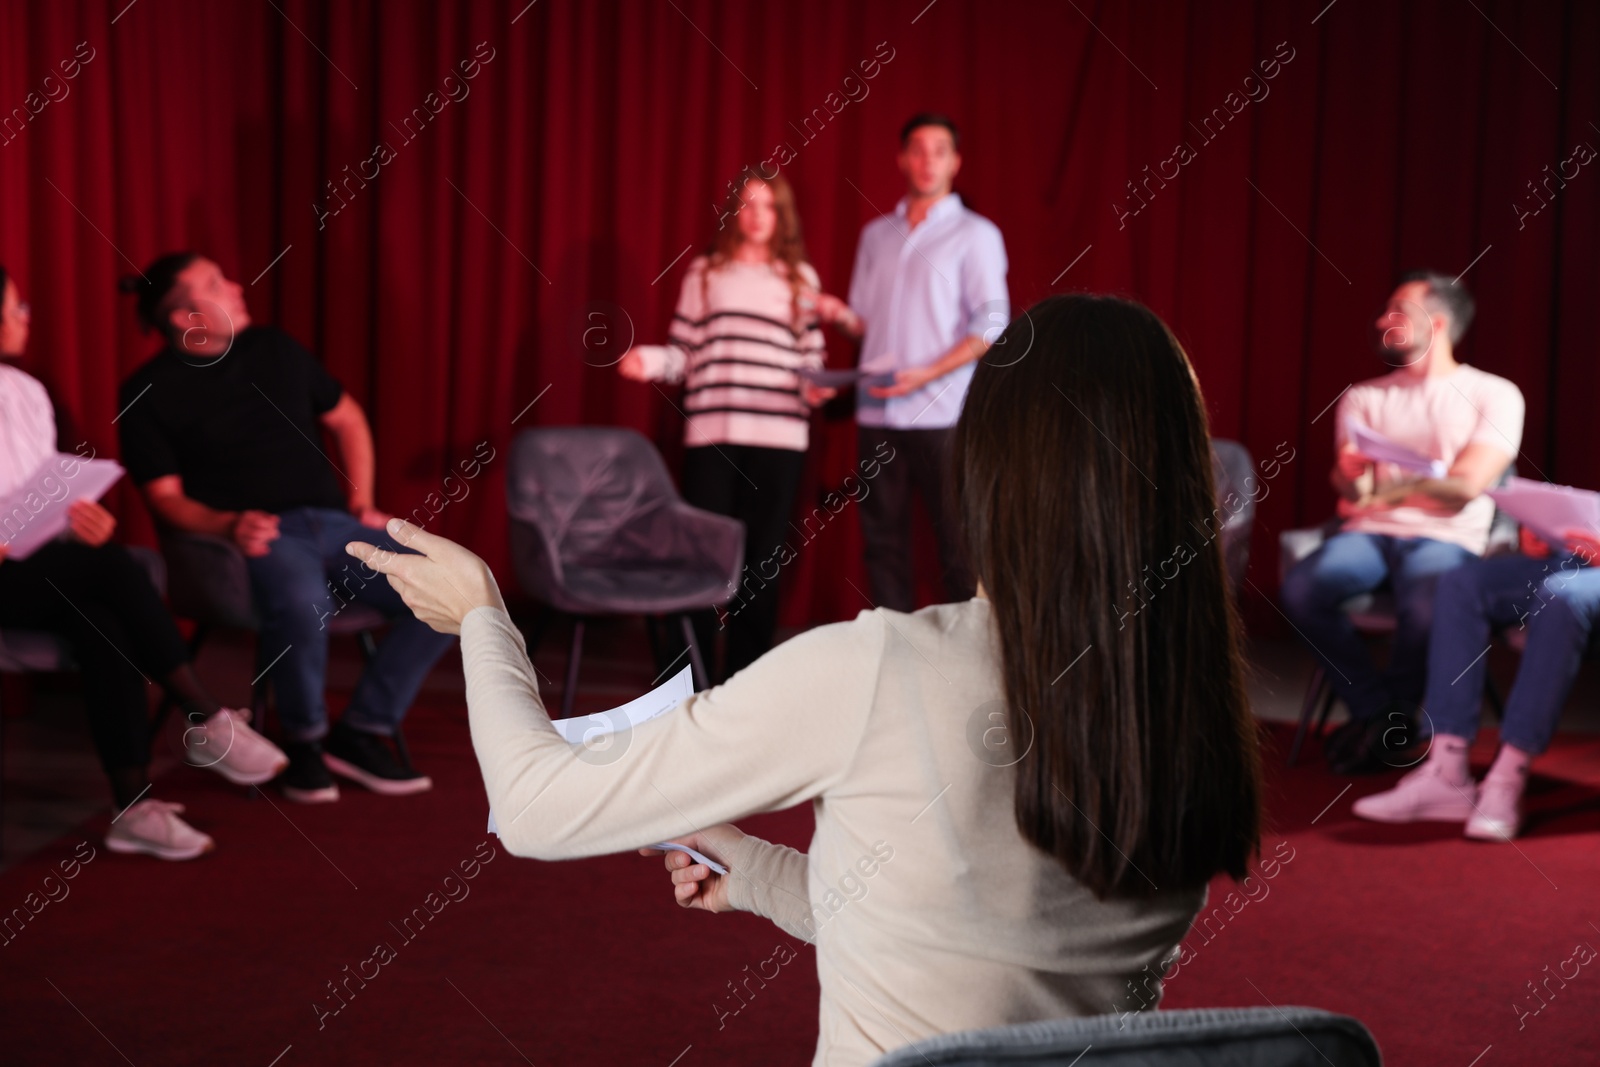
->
[[506, 426, 680, 566]]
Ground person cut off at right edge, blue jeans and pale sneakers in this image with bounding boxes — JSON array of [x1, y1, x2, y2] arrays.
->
[[1352, 528, 1600, 841]]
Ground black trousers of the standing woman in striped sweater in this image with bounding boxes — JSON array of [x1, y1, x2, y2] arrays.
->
[[683, 445, 805, 681]]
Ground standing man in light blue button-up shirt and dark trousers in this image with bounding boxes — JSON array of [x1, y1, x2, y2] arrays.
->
[[818, 114, 1011, 611]]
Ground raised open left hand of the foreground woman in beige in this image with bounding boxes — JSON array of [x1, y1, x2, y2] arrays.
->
[[344, 518, 506, 633]]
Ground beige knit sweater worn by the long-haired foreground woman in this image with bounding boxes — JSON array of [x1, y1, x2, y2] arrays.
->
[[461, 598, 1205, 1065]]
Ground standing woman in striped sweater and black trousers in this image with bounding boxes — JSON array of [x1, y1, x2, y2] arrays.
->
[[618, 170, 853, 678]]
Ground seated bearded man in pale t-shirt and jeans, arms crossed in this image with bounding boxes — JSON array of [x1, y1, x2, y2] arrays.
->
[[1278, 270, 1523, 774]]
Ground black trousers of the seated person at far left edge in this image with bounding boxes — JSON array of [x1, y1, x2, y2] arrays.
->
[[0, 541, 189, 771]]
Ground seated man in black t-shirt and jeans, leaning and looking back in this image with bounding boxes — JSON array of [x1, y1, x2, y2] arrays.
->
[[118, 253, 454, 803]]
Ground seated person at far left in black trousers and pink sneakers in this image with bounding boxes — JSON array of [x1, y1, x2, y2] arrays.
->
[[0, 267, 288, 859]]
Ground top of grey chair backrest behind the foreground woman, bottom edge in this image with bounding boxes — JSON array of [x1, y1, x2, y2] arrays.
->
[[872, 1008, 1382, 1067]]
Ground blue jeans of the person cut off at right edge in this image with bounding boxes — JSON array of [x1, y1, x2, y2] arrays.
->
[[1422, 555, 1600, 755]]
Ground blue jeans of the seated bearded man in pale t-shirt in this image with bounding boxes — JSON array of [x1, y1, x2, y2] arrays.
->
[[1278, 533, 1477, 718]]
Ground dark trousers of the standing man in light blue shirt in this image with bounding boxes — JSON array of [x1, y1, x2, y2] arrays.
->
[[856, 426, 974, 611]]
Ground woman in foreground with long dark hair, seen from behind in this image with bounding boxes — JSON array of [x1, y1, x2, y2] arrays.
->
[[349, 296, 1261, 1065]]
